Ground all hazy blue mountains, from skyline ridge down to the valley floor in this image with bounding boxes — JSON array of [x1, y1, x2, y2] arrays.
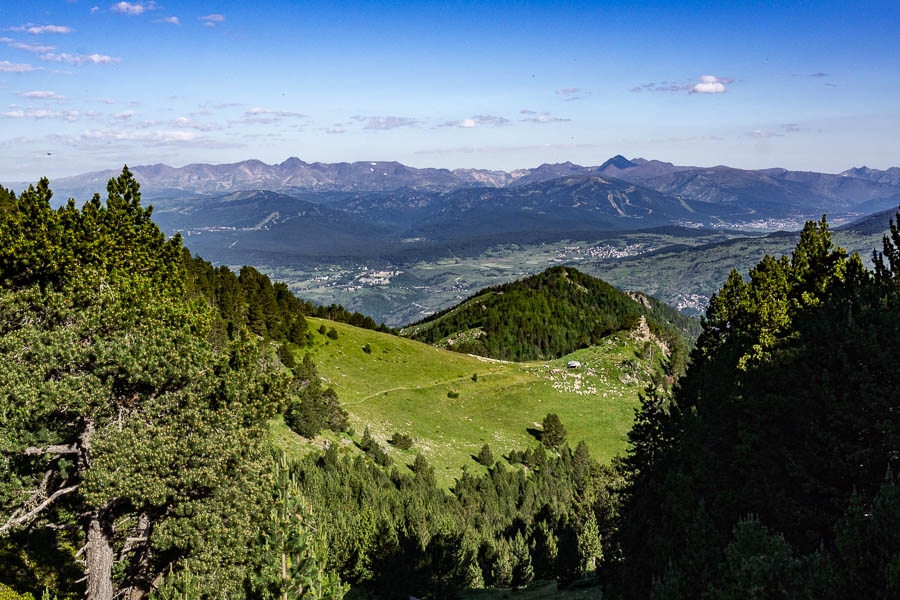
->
[[5, 156, 900, 262]]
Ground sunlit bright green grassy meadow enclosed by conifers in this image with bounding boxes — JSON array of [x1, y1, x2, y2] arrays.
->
[[273, 318, 661, 485]]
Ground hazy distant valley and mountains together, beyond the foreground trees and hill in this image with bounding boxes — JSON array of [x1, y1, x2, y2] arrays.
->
[[31, 155, 900, 326]]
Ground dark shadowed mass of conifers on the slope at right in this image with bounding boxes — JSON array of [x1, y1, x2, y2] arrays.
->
[[618, 213, 900, 598]]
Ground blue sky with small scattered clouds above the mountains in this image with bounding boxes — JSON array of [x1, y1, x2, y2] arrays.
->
[[0, 0, 900, 181]]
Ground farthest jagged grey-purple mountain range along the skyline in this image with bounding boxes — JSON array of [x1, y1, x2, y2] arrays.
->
[[14, 156, 900, 219]]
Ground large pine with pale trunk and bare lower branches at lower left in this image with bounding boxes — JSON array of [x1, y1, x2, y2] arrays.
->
[[0, 272, 287, 600]]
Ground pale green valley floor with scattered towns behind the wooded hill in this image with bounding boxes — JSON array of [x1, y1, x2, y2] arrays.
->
[[234, 226, 882, 327]]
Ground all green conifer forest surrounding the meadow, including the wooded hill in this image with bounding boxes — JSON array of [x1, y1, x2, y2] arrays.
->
[[0, 169, 900, 600]]
